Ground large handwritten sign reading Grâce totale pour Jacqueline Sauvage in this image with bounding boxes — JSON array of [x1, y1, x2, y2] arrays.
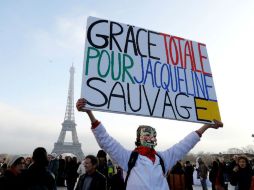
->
[[81, 17, 220, 123]]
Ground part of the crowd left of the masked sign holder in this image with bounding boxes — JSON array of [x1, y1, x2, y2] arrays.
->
[[0, 147, 124, 190]]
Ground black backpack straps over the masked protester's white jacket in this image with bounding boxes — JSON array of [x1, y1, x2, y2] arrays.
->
[[124, 151, 165, 189]]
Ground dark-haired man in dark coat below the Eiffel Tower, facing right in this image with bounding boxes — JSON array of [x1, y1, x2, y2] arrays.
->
[[75, 155, 107, 190]]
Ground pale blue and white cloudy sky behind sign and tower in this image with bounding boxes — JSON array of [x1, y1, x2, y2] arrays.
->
[[0, 0, 254, 157]]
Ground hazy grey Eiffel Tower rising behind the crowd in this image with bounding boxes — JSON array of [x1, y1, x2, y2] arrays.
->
[[52, 66, 84, 160]]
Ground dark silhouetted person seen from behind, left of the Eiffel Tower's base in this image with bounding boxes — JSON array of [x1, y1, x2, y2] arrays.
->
[[25, 147, 56, 190]]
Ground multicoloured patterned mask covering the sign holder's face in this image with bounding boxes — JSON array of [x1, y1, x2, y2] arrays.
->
[[138, 126, 157, 148]]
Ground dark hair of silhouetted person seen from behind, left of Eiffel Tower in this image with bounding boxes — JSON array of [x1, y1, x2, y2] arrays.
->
[[32, 147, 49, 167]]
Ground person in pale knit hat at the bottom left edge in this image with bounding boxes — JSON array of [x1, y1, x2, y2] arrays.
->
[[0, 155, 25, 190]]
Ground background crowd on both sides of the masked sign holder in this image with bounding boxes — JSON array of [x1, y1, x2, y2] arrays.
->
[[0, 147, 254, 190]]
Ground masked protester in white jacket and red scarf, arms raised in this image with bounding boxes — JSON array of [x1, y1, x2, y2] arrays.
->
[[76, 98, 223, 190]]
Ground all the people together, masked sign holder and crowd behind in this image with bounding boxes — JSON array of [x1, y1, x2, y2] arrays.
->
[[0, 99, 254, 190]]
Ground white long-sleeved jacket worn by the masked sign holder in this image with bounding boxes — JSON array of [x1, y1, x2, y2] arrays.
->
[[92, 124, 200, 190]]
